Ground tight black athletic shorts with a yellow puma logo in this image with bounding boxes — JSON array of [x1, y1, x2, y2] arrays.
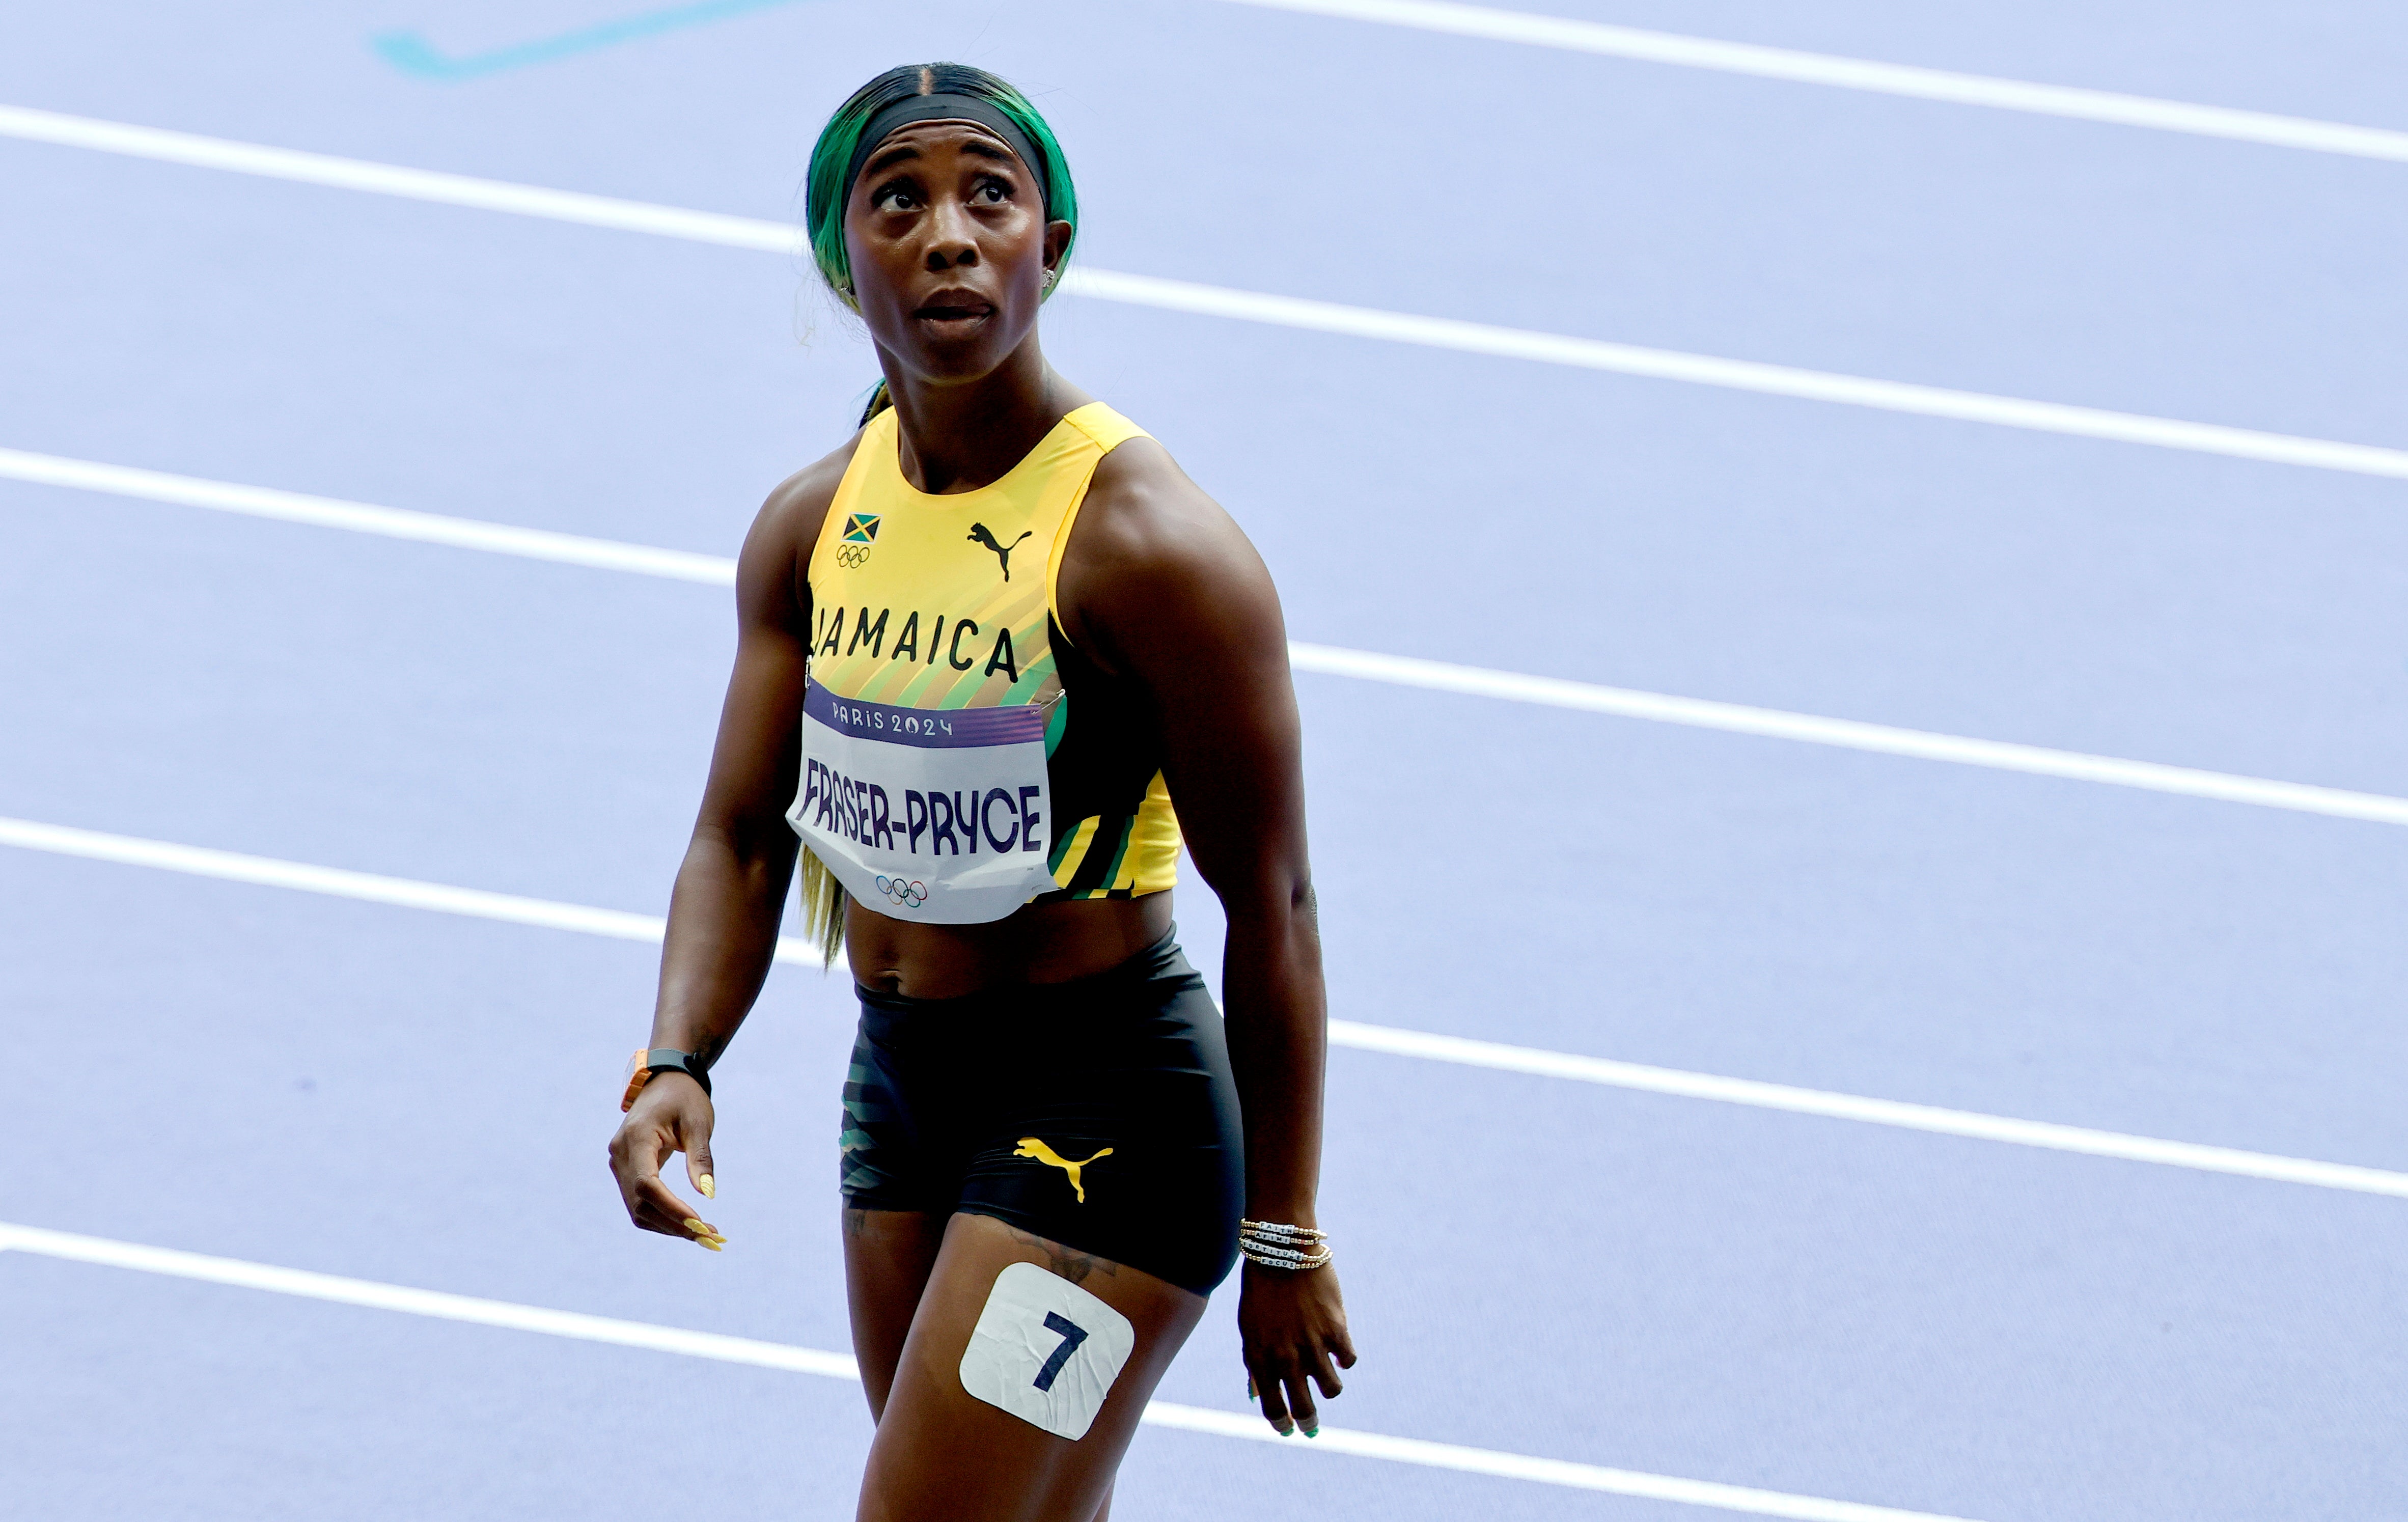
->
[[838, 934, 1245, 1295]]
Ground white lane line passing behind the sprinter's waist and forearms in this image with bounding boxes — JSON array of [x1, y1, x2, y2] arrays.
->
[[0, 819, 2408, 1199]]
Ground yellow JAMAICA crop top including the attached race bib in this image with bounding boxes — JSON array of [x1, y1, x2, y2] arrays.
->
[[790, 402, 1180, 925]]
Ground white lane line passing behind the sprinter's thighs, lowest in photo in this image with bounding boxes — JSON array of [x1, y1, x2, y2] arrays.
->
[[0, 1221, 1965, 1522]]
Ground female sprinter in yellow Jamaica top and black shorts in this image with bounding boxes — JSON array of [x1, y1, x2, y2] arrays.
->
[[612, 63, 1353, 1522]]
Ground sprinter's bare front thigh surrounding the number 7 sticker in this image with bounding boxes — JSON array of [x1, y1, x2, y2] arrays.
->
[[860, 1214, 1204, 1522]]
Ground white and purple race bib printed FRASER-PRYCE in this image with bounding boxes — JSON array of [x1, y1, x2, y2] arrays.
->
[[785, 681, 1055, 925]]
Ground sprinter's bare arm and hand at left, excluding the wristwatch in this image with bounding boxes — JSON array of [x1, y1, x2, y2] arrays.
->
[[609, 443, 852, 1240]]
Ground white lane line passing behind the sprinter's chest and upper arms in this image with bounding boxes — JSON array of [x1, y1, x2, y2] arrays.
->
[[18, 448, 2408, 823]]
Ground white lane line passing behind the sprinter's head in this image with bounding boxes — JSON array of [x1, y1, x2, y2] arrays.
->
[[14, 106, 2408, 479]]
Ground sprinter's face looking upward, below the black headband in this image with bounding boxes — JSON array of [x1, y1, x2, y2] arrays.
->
[[845, 120, 1071, 380]]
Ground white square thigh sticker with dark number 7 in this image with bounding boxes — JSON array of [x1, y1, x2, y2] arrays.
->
[[961, 1262, 1137, 1440]]
